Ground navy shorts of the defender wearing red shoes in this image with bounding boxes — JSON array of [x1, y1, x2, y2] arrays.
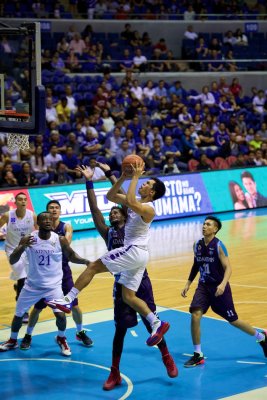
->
[[114, 275, 156, 328]]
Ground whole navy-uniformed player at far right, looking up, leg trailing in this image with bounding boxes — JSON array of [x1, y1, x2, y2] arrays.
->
[[181, 215, 267, 367]]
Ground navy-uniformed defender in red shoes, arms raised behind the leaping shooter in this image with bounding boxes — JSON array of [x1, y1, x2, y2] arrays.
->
[[77, 163, 178, 390]]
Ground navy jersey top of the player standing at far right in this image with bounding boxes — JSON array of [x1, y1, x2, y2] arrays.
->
[[194, 237, 228, 285]]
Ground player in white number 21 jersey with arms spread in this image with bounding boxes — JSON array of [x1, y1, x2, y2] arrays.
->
[[0, 211, 89, 356]]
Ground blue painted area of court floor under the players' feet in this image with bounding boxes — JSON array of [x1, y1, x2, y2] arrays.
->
[[0, 310, 267, 400]]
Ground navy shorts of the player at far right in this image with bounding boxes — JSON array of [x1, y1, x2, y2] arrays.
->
[[189, 283, 238, 322]]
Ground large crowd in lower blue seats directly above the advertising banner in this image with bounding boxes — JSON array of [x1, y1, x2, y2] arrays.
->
[[0, 65, 267, 187]]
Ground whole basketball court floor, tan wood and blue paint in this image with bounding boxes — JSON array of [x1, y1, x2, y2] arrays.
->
[[0, 209, 267, 400]]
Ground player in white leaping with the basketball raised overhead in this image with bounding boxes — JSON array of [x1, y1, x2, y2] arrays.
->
[[47, 162, 170, 346]]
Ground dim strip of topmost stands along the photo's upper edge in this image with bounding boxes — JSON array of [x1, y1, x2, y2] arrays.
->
[[0, 0, 267, 21]]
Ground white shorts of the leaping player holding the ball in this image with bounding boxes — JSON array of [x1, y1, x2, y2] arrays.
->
[[101, 245, 149, 292]]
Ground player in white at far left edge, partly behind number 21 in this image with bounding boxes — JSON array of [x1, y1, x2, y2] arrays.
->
[[0, 192, 37, 322]]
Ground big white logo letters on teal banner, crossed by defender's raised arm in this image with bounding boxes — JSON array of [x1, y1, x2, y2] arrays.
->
[[45, 188, 114, 217]]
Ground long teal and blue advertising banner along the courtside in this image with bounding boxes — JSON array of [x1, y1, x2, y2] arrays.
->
[[0, 167, 267, 230]]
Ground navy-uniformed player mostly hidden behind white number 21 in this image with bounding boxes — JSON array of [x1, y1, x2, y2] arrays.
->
[[20, 200, 93, 350]]
